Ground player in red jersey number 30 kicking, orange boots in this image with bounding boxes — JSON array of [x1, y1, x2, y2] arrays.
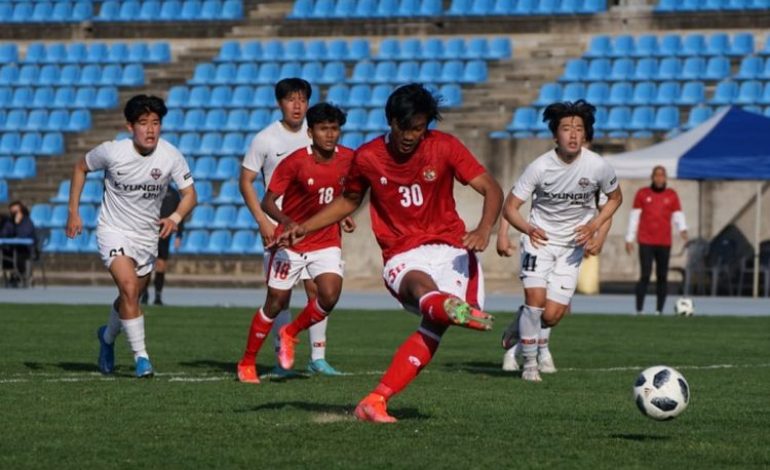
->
[[277, 84, 503, 423]]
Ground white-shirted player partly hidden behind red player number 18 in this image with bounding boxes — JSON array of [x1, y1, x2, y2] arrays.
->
[[240, 78, 339, 381]]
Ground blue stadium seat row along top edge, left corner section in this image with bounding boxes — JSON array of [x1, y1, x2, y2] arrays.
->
[[0, 0, 243, 23]]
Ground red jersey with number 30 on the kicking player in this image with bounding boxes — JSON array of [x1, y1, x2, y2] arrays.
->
[[345, 130, 486, 262]]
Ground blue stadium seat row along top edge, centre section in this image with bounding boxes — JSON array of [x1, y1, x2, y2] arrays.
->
[[288, 0, 607, 20]]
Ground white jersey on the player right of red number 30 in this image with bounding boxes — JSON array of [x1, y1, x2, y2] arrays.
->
[[511, 148, 618, 246]]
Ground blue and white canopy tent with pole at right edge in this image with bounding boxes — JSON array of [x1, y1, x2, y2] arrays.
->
[[607, 107, 770, 297]]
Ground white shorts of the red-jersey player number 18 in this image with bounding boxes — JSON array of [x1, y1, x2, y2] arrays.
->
[[267, 246, 344, 290]]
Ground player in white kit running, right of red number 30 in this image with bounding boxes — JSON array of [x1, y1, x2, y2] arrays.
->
[[498, 100, 623, 382]]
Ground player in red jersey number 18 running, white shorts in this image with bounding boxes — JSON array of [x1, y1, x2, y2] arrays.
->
[[238, 103, 353, 383]]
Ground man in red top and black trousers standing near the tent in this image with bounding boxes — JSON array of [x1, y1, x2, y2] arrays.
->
[[626, 165, 687, 315]]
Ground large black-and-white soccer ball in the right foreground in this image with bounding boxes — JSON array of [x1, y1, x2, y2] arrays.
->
[[634, 366, 690, 421]]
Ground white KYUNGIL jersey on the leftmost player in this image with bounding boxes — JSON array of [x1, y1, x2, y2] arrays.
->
[[86, 139, 193, 243]]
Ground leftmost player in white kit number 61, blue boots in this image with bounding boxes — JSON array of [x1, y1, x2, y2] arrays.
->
[[67, 95, 196, 377]]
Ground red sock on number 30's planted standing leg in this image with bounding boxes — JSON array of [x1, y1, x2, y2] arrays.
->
[[374, 330, 441, 400]]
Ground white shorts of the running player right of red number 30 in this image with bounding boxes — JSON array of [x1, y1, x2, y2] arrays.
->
[[519, 235, 583, 305]]
